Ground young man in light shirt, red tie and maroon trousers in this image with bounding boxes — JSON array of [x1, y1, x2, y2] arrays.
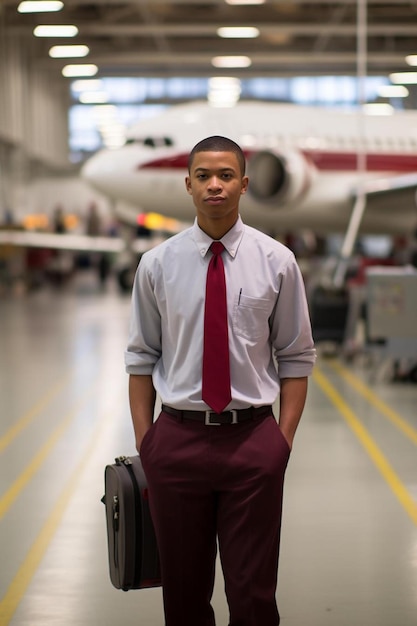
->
[[126, 136, 315, 626]]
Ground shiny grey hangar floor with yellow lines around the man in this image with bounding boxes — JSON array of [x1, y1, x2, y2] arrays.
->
[[0, 274, 417, 626]]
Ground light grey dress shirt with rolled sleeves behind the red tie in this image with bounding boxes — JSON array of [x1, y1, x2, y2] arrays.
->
[[125, 217, 315, 411]]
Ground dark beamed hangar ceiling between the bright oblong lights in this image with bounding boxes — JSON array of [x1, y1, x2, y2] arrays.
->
[[0, 0, 417, 77]]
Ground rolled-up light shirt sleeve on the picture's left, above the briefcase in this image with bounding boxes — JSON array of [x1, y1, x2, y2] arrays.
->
[[125, 257, 161, 375]]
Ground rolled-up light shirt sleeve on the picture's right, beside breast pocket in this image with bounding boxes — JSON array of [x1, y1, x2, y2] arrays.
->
[[270, 256, 316, 378]]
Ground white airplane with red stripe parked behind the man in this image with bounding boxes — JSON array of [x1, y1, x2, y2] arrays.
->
[[82, 102, 417, 245]]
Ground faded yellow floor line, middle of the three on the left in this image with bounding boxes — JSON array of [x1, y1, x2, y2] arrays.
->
[[0, 383, 97, 520]]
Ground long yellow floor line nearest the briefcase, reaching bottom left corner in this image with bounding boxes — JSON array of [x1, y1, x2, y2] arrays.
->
[[0, 386, 122, 626]]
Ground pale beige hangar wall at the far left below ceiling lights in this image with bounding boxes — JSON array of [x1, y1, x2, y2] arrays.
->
[[0, 34, 70, 221]]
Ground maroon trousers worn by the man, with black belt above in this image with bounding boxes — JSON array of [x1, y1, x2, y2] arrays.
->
[[140, 412, 290, 626]]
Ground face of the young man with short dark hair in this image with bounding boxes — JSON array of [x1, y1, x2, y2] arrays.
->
[[185, 152, 248, 227]]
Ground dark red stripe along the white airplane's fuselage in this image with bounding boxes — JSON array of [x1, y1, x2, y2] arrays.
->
[[138, 150, 417, 172]]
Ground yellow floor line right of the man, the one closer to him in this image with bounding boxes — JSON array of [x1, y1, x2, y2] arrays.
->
[[313, 366, 417, 526]]
